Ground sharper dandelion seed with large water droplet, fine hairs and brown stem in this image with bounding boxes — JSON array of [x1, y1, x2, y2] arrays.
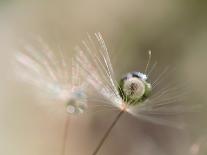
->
[[75, 33, 196, 155]]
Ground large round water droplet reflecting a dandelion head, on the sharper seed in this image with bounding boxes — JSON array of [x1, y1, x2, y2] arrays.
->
[[119, 72, 152, 105]]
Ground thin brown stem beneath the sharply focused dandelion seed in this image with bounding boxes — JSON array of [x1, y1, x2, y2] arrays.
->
[[92, 110, 124, 155]]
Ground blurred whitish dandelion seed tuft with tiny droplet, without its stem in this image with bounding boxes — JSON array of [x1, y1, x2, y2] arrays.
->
[[14, 38, 87, 114]]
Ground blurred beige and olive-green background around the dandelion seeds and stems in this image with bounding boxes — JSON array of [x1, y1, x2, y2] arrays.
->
[[0, 0, 207, 155]]
